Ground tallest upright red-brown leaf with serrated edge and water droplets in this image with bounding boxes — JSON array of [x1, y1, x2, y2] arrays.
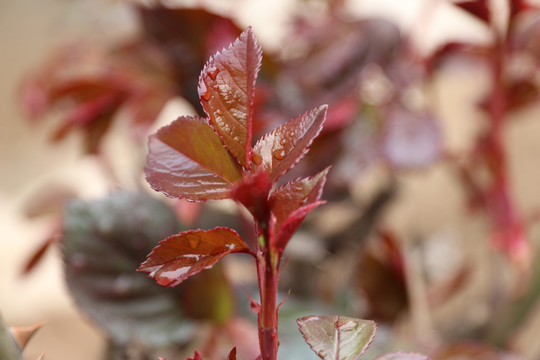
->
[[199, 28, 262, 167]]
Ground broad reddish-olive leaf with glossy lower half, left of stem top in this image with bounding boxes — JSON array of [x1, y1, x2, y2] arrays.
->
[[145, 117, 242, 201]]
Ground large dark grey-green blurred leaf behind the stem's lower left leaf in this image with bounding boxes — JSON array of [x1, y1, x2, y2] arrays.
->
[[62, 192, 190, 346]]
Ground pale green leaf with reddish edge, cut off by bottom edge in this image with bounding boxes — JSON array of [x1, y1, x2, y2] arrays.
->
[[296, 316, 377, 360]]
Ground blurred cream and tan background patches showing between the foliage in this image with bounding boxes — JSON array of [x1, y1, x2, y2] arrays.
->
[[0, 0, 540, 360]]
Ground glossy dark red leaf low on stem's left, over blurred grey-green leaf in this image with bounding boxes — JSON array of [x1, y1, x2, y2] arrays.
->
[[137, 227, 249, 287]]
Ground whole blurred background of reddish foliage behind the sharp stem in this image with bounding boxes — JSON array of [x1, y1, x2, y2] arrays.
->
[[0, 0, 540, 360]]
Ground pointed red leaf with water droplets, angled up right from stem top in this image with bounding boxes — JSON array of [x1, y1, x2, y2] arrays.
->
[[253, 105, 328, 180]]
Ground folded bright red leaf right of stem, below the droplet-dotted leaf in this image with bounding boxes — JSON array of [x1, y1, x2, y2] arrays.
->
[[270, 168, 329, 250]]
